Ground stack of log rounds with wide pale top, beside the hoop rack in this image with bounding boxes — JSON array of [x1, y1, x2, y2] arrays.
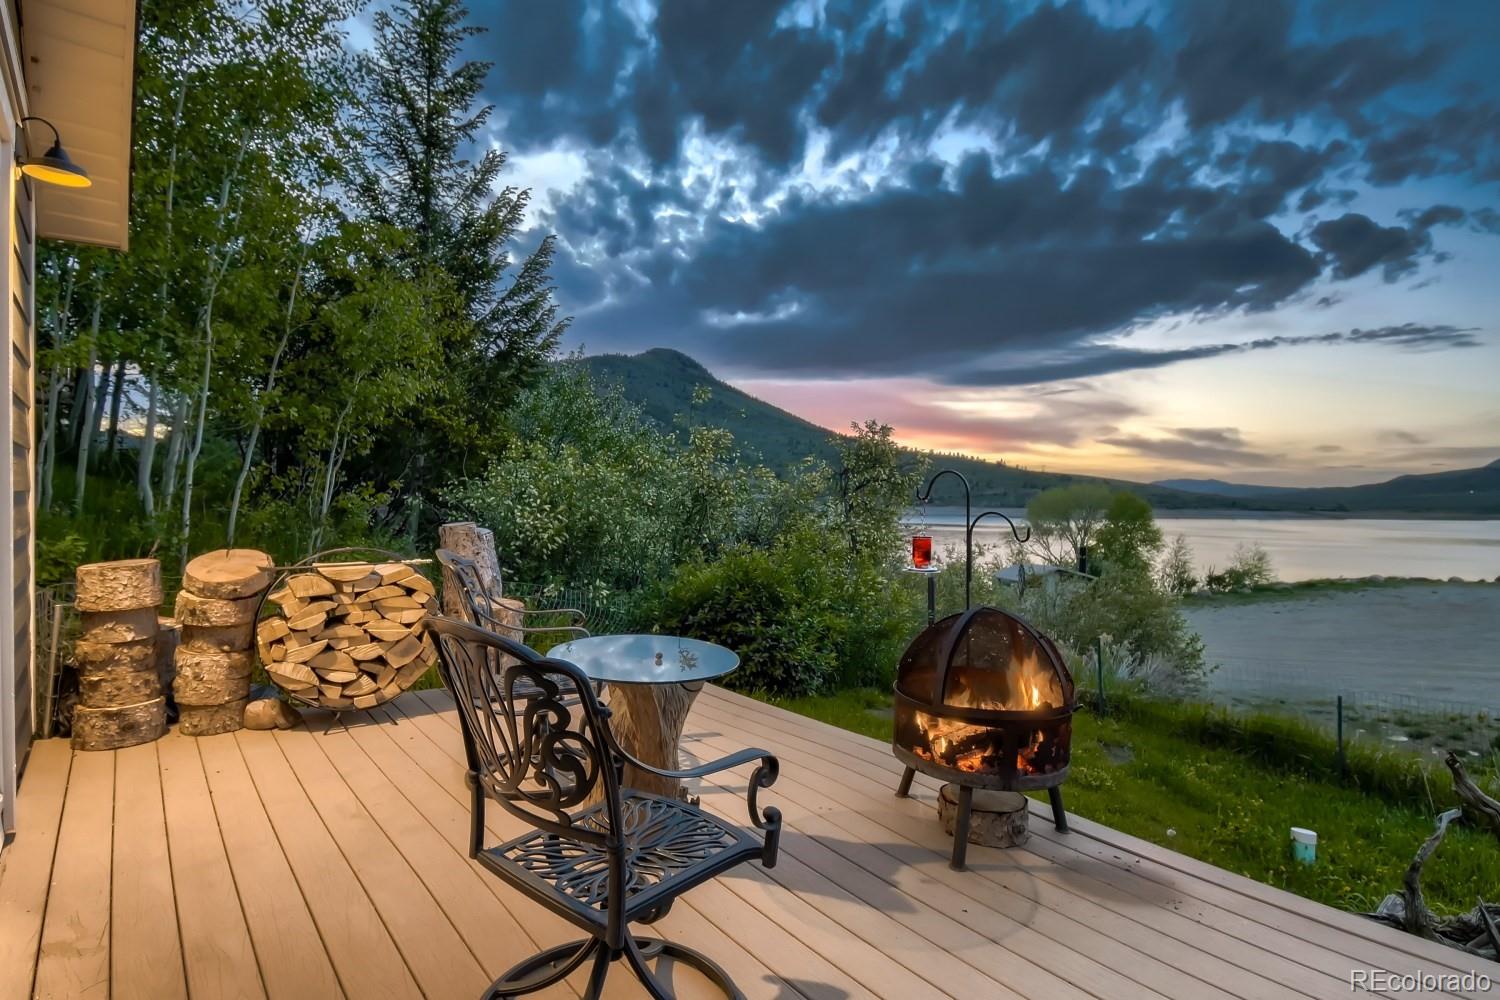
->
[[173, 549, 272, 736]]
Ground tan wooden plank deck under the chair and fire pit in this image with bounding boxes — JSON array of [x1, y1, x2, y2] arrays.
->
[[0, 688, 1500, 1000]]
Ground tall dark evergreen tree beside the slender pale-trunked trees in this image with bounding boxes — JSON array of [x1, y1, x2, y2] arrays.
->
[[354, 0, 567, 514]]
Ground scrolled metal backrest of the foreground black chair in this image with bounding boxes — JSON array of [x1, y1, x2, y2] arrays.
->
[[426, 615, 624, 847]]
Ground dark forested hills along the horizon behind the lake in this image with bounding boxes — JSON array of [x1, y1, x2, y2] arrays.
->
[[584, 348, 1500, 517]]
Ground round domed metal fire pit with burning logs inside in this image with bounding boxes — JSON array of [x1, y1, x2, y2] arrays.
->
[[893, 607, 1076, 870]]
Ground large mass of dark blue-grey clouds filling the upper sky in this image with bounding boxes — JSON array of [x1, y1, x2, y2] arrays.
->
[[473, 0, 1500, 385]]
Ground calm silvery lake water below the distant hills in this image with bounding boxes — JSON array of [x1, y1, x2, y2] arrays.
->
[[906, 507, 1500, 580]]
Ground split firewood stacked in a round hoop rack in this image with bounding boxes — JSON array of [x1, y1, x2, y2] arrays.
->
[[257, 562, 438, 711]]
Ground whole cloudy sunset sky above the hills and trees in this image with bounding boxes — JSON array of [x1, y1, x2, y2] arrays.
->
[[441, 0, 1500, 483]]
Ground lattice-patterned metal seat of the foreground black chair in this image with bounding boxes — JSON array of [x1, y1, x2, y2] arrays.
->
[[480, 789, 762, 925]]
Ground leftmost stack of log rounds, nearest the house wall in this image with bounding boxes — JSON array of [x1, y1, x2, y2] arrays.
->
[[74, 559, 167, 750]]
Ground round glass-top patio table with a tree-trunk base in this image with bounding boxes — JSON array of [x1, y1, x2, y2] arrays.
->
[[548, 636, 740, 798]]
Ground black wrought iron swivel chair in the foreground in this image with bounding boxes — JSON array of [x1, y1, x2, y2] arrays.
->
[[429, 616, 782, 1000]]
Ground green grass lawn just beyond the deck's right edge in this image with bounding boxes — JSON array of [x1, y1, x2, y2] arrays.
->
[[762, 690, 1500, 912]]
